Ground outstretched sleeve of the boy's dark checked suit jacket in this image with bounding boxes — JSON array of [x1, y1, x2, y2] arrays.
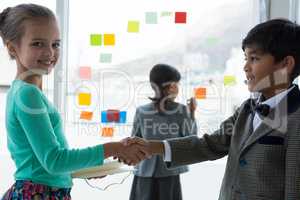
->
[[167, 109, 240, 167]]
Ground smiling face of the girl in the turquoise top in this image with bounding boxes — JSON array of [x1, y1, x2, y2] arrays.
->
[[12, 18, 60, 74]]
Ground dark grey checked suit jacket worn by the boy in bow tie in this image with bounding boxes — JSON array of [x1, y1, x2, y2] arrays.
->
[[167, 85, 300, 200]]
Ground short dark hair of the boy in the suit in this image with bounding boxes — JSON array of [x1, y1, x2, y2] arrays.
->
[[242, 19, 300, 81]]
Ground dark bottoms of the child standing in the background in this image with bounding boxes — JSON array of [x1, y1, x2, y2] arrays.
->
[[129, 175, 182, 200]]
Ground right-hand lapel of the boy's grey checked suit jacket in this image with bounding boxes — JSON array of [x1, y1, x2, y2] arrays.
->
[[241, 85, 300, 154]]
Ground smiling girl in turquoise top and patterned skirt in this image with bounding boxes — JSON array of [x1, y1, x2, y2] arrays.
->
[[0, 4, 145, 200]]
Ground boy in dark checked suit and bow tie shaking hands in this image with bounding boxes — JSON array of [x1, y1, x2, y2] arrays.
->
[[126, 19, 300, 200]]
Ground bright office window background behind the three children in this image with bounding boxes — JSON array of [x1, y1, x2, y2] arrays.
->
[[0, 0, 299, 200]]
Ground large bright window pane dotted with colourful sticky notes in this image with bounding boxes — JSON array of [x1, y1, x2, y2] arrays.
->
[[65, 0, 259, 199]]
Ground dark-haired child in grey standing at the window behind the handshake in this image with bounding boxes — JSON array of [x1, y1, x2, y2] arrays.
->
[[130, 64, 197, 200]]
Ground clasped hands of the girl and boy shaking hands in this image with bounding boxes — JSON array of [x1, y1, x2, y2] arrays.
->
[[103, 137, 164, 165]]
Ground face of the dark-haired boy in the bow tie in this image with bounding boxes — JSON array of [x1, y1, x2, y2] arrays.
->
[[244, 47, 288, 94]]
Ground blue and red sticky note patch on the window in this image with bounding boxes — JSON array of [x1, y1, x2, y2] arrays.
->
[[101, 110, 127, 123]]
